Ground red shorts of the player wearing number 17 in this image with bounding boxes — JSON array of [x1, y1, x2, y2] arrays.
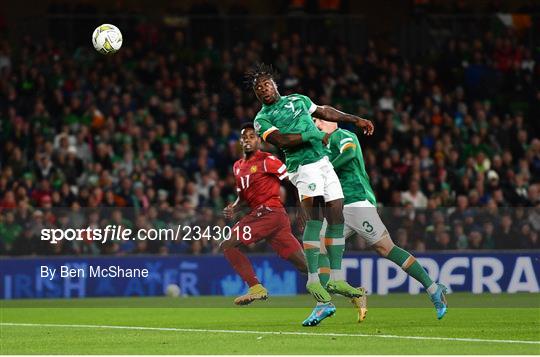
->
[[231, 206, 302, 259]]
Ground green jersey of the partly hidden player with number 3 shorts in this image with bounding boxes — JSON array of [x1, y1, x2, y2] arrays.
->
[[327, 129, 377, 205]]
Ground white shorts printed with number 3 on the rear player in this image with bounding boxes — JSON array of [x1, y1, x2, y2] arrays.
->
[[320, 201, 386, 253]]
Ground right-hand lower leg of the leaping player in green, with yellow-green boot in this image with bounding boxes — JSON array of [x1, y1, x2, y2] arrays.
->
[[325, 199, 362, 298]]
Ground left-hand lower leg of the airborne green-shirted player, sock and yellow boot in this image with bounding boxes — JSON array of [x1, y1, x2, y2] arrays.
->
[[301, 196, 332, 303]]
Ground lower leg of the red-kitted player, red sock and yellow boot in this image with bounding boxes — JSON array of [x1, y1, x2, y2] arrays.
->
[[221, 239, 268, 305]]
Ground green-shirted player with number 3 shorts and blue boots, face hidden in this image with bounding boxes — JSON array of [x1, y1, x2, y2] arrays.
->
[[315, 119, 446, 321]]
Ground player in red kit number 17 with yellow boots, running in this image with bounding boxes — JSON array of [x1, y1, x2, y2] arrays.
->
[[221, 123, 307, 305]]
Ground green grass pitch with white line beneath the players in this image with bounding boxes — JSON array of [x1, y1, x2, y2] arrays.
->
[[0, 293, 540, 355]]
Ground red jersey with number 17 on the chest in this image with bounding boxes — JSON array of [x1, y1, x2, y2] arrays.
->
[[233, 150, 287, 209]]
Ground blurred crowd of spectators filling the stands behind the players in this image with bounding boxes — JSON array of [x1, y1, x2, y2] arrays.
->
[[0, 22, 540, 255]]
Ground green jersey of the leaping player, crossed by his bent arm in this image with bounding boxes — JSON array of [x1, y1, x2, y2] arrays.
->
[[253, 94, 327, 172]]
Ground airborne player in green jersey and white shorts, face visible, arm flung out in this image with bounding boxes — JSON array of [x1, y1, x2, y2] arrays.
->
[[246, 64, 373, 322]]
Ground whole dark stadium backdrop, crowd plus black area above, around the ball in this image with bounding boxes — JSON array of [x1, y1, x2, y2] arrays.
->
[[0, 0, 540, 255]]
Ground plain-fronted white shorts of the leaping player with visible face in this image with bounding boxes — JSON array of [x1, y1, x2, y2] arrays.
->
[[289, 156, 343, 202]]
